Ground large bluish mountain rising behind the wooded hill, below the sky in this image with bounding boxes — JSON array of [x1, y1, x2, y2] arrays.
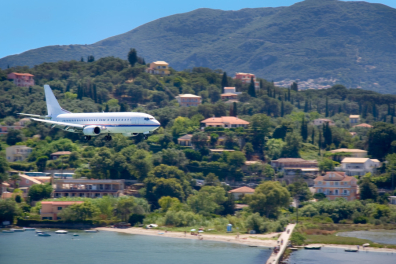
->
[[0, 0, 396, 93]]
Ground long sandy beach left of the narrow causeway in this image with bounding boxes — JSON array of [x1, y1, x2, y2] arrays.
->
[[96, 227, 280, 247]]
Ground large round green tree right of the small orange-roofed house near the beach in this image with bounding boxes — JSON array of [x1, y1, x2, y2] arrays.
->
[[247, 181, 290, 217]]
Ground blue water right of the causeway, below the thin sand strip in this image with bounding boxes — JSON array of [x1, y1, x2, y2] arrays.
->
[[288, 247, 396, 264]]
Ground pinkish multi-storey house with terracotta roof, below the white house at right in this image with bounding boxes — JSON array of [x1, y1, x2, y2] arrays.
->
[[314, 171, 357, 201]]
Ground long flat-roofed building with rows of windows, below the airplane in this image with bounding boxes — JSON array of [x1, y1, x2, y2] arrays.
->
[[54, 179, 125, 198]]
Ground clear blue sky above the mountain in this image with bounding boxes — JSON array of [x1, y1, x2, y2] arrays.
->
[[0, 0, 396, 58]]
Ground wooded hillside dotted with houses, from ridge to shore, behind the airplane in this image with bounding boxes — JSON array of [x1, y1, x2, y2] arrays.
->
[[0, 54, 396, 233]]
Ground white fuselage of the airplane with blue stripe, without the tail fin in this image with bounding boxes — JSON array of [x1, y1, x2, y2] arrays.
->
[[50, 112, 160, 136]]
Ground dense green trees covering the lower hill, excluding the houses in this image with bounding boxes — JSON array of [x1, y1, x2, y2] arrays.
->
[[0, 57, 396, 232]]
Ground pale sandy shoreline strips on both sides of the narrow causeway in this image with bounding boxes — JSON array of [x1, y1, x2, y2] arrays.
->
[[95, 227, 396, 253]]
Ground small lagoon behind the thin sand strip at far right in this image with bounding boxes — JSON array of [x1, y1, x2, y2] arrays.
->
[[338, 230, 396, 245]]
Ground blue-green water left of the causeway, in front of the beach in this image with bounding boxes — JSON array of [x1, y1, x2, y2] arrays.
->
[[0, 231, 271, 264]]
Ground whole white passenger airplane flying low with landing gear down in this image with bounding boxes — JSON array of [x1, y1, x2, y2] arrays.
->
[[19, 85, 161, 141]]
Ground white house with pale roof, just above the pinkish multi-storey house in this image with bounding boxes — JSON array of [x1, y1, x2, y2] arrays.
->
[[336, 158, 381, 176]]
